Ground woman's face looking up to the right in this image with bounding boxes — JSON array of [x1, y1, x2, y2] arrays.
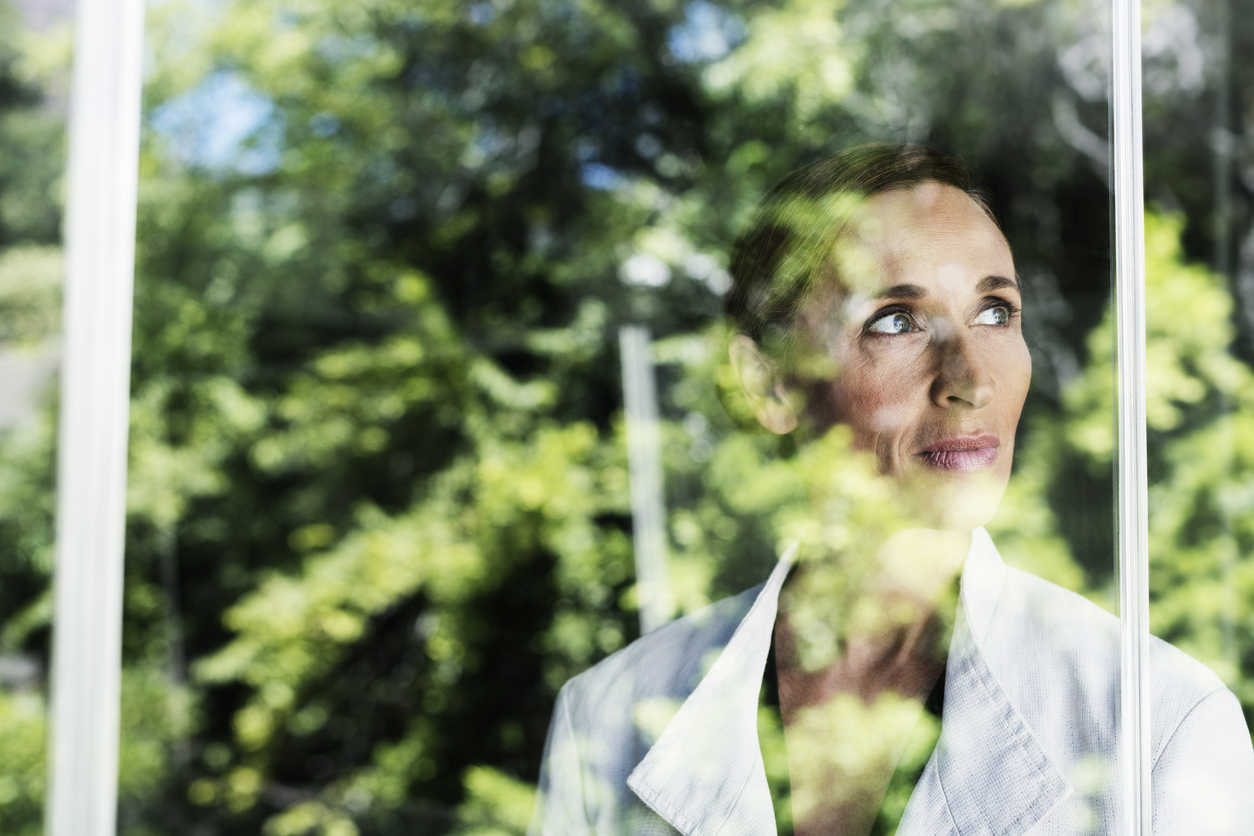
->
[[793, 183, 1032, 529]]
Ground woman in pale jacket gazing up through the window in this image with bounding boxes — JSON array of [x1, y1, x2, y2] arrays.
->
[[532, 145, 1254, 836]]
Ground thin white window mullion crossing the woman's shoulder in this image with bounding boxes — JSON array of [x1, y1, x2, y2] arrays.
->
[[1111, 0, 1152, 836]]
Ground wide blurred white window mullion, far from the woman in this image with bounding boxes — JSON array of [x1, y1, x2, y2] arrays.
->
[[45, 0, 143, 836]]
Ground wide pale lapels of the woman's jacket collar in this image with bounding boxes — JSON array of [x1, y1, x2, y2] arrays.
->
[[627, 529, 1071, 836]]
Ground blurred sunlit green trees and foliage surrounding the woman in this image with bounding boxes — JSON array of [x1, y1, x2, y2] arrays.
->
[[0, 0, 1254, 836]]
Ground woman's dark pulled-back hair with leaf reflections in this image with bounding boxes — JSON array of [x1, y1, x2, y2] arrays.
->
[[724, 143, 997, 351]]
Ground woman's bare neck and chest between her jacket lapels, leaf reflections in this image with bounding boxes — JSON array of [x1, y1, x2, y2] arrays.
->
[[775, 530, 971, 836]]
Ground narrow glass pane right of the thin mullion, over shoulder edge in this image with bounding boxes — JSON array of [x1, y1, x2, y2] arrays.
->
[[1144, 0, 1254, 832]]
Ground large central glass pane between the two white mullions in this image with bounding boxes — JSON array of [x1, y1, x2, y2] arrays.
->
[[100, 0, 1240, 835]]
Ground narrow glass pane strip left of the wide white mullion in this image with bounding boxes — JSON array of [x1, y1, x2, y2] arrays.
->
[[0, 3, 70, 835]]
